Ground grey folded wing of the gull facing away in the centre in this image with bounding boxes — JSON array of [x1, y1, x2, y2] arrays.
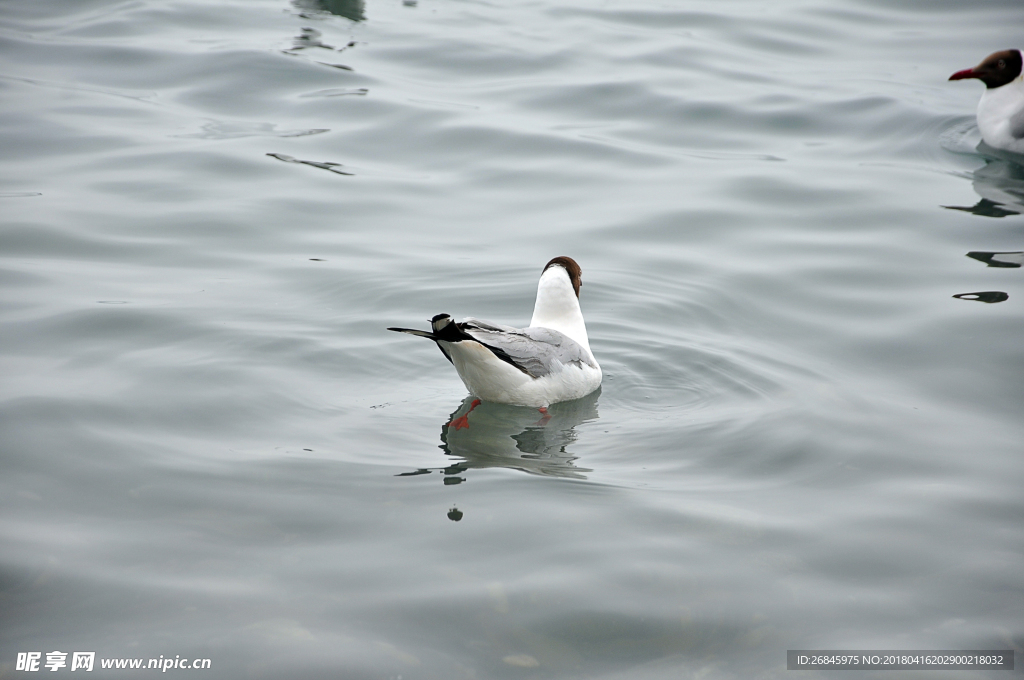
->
[[463, 320, 596, 378]]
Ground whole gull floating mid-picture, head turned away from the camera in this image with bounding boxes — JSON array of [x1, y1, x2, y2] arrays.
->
[[388, 257, 601, 416]]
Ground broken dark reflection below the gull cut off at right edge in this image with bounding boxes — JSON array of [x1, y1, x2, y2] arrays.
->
[[942, 148, 1024, 304]]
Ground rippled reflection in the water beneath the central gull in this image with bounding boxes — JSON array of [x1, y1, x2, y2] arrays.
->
[[398, 390, 601, 485]]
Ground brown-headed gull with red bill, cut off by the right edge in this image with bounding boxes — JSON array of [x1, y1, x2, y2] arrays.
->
[[949, 49, 1024, 154]]
